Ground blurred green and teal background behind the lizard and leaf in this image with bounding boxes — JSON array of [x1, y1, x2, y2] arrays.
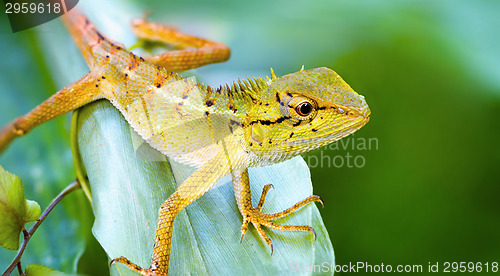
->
[[0, 0, 500, 274]]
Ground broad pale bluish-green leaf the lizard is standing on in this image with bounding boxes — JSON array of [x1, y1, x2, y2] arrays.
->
[[78, 101, 334, 275]]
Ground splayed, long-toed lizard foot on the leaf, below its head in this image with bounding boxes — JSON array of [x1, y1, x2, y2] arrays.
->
[[240, 184, 323, 255]]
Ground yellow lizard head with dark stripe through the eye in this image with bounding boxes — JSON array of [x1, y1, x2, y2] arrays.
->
[[244, 67, 370, 163]]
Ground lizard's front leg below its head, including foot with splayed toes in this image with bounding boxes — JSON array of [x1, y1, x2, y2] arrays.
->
[[232, 169, 323, 254]]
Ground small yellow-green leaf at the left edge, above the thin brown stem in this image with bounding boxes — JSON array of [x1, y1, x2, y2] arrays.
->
[[0, 166, 41, 250]]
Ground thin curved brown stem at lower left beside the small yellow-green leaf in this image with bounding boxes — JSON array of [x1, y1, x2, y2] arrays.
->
[[2, 179, 80, 276]]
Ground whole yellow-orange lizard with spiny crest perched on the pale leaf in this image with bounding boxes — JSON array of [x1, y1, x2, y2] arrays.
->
[[0, 9, 371, 275]]
